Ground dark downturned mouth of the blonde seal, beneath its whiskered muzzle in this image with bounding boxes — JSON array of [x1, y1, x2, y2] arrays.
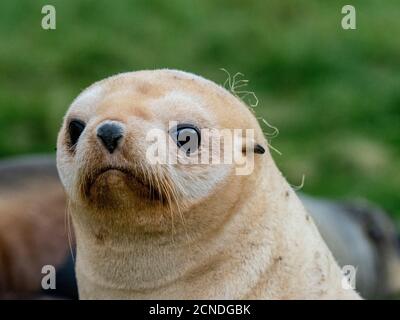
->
[[81, 166, 164, 202]]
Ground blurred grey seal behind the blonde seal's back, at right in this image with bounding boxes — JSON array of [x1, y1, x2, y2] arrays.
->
[[300, 194, 400, 298]]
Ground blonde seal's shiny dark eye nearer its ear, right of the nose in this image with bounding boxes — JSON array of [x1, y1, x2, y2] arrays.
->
[[172, 124, 201, 155]]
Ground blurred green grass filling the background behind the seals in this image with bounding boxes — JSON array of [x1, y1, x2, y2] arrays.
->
[[0, 0, 400, 217]]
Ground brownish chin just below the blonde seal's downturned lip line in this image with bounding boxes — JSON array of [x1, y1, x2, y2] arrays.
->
[[82, 167, 163, 207]]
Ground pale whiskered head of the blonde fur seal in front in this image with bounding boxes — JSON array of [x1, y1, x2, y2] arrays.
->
[[57, 70, 265, 239]]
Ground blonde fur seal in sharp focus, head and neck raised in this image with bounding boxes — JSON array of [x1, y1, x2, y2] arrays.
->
[[57, 70, 359, 299]]
